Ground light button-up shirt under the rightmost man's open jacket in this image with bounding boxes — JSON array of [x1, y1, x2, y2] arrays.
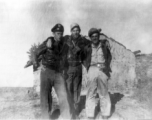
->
[[91, 43, 105, 65]]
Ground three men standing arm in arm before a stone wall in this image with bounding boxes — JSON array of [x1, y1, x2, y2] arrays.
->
[[32, 23, 111, 119]]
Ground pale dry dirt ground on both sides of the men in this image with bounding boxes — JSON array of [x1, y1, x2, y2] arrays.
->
[[0, 88, 152, 120]]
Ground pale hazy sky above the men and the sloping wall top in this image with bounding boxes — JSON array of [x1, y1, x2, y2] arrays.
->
[[0, 0, 152, 87]]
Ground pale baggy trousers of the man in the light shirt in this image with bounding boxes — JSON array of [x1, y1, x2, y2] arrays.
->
[[86, 66, 111, 117]]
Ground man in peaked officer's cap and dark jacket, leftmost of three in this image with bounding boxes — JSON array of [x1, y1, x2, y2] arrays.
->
[[34, 24, 71, 119]]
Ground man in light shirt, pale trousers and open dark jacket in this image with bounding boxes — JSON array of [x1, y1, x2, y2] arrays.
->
[[85, 28, 111, 119]]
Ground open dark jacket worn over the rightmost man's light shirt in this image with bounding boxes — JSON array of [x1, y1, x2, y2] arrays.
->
[[84, 40, 112, 77]]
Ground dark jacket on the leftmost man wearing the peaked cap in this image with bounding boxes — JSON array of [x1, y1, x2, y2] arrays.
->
[[36, 37, 63, 69]]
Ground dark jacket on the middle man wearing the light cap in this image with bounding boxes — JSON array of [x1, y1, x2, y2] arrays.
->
[[64, 35, 90, 67]]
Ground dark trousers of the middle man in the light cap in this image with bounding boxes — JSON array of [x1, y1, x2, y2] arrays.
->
[[66, 65, 82, 113]]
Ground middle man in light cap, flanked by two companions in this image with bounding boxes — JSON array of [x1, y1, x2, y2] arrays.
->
[[64, 23, 88, 115]]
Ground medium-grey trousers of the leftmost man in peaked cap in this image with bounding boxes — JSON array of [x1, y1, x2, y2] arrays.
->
[[40, 66, 71, 119]]
